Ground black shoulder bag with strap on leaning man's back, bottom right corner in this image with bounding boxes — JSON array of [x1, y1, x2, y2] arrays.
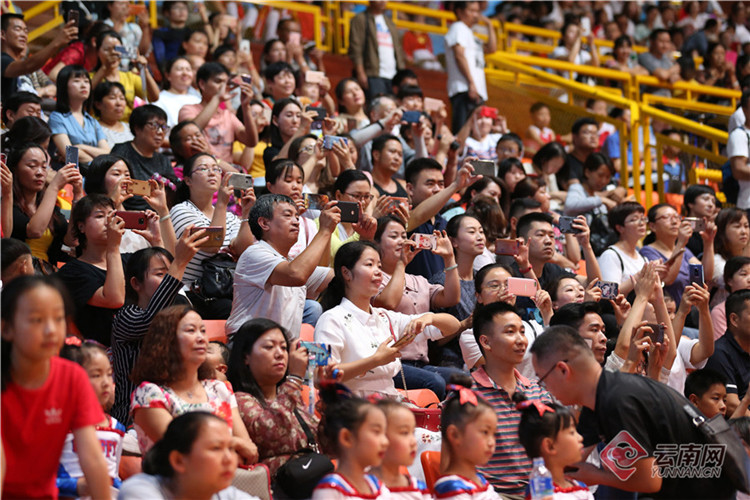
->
[[682, 404, 750, 493]]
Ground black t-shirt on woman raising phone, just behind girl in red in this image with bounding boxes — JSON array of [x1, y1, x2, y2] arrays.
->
[[57, 254, 132, 347]]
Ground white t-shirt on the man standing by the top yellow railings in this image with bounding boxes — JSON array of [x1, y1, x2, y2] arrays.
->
[[445, 21, 487, 101]]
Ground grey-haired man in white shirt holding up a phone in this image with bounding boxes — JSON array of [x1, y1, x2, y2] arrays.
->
[[226, 194, 341, 339]]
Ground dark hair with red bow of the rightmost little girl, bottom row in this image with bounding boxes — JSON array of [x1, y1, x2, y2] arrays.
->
[[513, 392, 576, 458]]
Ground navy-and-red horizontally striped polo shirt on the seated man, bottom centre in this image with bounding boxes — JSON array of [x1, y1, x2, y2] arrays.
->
[[471, 368, 552, 495]]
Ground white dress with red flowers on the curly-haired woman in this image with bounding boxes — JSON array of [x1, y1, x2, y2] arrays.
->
[[130, 380, 237, 453]]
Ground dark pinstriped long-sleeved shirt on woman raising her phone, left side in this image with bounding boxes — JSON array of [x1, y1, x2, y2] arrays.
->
[[111, 274, 182, 425]]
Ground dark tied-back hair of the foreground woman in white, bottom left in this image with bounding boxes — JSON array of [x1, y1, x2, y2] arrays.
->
[[143, 411, 226, 478]]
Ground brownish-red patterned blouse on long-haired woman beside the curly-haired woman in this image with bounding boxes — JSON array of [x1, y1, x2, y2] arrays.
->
[[236, 379, 318, 477]]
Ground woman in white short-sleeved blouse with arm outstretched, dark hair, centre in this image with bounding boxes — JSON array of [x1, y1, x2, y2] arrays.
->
[[315, 241, 459, 396]]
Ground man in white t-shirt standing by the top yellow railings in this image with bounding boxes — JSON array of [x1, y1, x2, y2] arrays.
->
[[445, 2, 497, 134]]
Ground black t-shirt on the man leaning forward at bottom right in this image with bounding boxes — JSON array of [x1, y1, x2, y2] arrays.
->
[[594, 370, 734, 499]]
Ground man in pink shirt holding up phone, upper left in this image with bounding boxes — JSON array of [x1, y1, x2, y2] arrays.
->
[[178, 62, 258, 163]]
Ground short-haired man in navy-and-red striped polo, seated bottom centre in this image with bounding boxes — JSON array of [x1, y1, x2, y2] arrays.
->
[[472, 302, 552, 498]]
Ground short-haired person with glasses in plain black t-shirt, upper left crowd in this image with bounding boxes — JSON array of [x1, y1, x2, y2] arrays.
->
[[111, 104, 177, 210]]
